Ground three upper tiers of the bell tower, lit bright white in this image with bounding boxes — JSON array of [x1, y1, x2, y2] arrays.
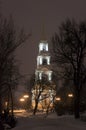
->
[[35, 40, 52, 81]]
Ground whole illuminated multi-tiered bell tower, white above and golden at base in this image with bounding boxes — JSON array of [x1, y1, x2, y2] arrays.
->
[[32, 36, 56, 110]]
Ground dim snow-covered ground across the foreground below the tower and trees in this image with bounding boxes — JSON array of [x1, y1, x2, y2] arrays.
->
[[12, 113, 86, 130]]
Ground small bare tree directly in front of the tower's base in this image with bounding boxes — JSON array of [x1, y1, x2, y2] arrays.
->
[[33, 77, 56, 115]]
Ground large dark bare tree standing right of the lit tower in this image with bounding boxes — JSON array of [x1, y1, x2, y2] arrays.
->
[[52, 19, 86, 118]]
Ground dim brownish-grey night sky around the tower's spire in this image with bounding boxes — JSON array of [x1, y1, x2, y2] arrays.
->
[[1, 0, 86, 74]]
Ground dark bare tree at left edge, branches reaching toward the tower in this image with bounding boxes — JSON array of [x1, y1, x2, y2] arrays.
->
[[0, 16, 29, 114]]
